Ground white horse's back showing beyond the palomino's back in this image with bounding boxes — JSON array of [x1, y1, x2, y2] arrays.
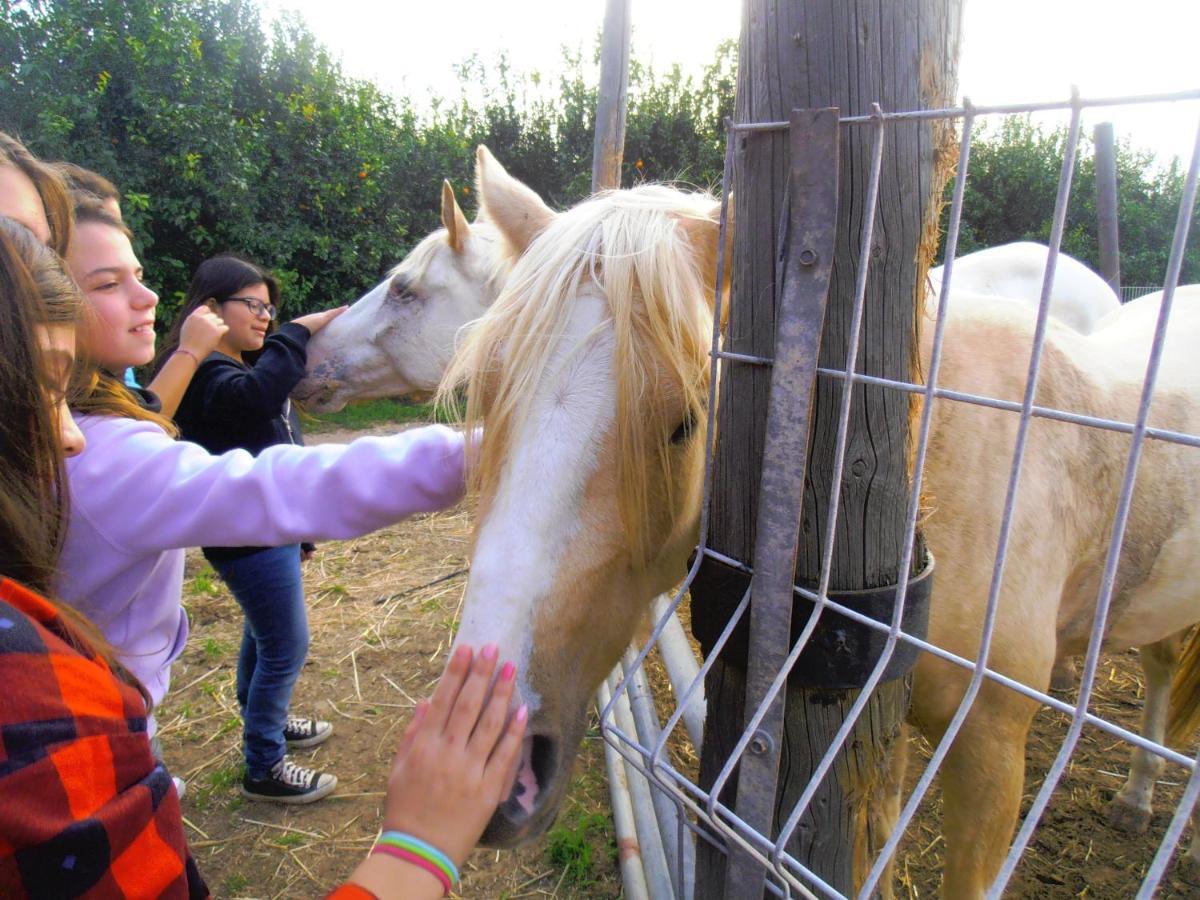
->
[[925, 241, 1121, 335]]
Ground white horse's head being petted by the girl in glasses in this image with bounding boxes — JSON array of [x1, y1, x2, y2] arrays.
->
[[293, 148, 550, 413]]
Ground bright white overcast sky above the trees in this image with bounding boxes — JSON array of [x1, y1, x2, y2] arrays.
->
[[264, 0, 1200, 164]]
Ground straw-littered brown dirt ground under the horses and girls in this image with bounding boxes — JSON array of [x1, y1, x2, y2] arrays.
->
[[158, 433, 1200, 900]]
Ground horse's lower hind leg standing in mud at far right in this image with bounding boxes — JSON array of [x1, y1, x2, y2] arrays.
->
[[1108, 631, 1186, 834]]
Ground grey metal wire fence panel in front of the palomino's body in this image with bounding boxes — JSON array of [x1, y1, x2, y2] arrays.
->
[[598, 90, 1200, 900]]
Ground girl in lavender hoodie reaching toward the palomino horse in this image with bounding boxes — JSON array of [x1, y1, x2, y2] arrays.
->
[[58, 202, 463, 803]]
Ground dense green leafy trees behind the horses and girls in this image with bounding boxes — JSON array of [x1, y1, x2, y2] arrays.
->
[[0, 0, 1200, 320]]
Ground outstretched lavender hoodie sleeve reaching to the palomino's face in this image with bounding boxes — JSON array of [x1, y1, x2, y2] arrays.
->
[[67, 416, 463, 554]]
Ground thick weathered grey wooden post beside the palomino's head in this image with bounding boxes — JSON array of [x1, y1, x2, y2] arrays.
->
[[692, 0, 962, 898]]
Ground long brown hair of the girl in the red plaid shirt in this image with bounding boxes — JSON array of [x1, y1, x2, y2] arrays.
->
[[0, 216, 142, 702]]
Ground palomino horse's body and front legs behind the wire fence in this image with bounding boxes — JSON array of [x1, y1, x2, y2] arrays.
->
[[912, 292, 1200, 898]]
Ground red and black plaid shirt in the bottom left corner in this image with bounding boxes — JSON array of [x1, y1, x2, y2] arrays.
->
[[0, 581, 208, 898]]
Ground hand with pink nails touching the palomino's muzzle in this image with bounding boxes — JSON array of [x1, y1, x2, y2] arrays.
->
[[384, 644, 528, 864]]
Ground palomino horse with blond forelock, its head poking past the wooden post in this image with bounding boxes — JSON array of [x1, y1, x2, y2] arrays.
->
[[443, 157, 1200, 896]]
